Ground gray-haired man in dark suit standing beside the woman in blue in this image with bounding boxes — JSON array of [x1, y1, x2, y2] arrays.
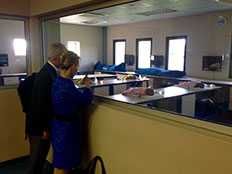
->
[[28, 43, 67, 174]]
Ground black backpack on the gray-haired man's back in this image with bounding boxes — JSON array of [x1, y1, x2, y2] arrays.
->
[[17, 73, 36, 115]]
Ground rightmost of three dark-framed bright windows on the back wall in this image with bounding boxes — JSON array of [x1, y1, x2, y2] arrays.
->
[[166, 36, 187, 71]]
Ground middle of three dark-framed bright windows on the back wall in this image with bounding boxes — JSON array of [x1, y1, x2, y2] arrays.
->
[[136, 38, 152, 68]]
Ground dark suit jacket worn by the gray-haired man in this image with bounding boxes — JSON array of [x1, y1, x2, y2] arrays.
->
[[31, 63, 57, 136]]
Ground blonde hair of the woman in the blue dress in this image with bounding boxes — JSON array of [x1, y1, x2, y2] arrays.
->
[[60, 51, 80, 70]]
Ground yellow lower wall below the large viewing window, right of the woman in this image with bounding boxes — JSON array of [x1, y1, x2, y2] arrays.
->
[[90, 102, 232, 174]]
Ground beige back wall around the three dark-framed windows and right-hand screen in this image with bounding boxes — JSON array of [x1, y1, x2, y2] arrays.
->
[[107, 12, 232, 79]]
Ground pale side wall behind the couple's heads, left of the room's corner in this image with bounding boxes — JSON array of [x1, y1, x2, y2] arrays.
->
[[60, 23, 103, 71]]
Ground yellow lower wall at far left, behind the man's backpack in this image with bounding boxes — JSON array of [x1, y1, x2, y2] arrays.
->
[[0, 89, 28, 162]]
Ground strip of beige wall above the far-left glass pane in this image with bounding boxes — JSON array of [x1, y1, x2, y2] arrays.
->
[[0, 0, 30, 16]]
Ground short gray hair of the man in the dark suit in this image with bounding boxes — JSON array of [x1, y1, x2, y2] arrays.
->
[[48, 42, 68, 60]]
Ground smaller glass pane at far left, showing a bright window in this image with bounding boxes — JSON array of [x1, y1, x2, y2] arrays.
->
[[0, 17, 28, 86]]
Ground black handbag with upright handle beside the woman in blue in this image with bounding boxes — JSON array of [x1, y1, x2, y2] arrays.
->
[[70, 156, 106, 174]]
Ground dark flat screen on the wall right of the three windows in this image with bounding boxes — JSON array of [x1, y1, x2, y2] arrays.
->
[[202, 56, 222, 71]]
